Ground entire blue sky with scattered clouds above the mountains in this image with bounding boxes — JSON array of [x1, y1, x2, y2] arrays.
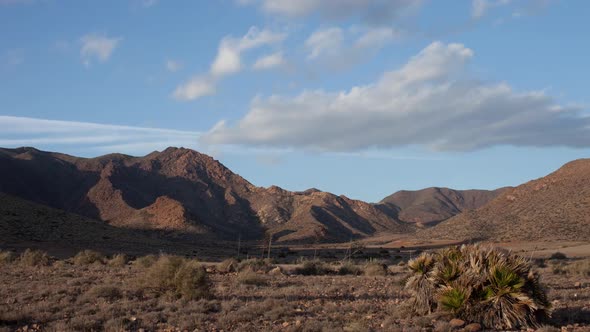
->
[[0, 0, 590, 202]]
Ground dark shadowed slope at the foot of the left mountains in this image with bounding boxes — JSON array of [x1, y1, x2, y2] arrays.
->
[[0, 193, 222, 257]]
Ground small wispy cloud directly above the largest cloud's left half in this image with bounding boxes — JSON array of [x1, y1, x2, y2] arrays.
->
[[304, 26, 401, 69]]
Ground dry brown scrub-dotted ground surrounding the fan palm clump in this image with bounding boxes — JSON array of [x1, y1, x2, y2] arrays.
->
[[0, 250, 590, 331]]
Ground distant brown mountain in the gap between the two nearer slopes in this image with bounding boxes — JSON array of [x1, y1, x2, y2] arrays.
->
[[379, 187, 507, 225]]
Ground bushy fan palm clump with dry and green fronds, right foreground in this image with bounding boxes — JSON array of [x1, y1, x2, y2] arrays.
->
[[406, 245, 550, 330]]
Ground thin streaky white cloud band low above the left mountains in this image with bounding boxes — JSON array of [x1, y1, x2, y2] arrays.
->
[[0, 116, 201, 152]]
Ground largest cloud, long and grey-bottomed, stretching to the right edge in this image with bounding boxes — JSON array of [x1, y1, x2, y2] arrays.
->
[[202, 42, 590, 152]]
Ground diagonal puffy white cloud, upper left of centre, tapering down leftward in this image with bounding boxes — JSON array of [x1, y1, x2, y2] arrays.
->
[[173, 27, 287, 101]]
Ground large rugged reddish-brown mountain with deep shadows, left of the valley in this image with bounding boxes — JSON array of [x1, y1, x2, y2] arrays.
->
[[0, 148, 413, 242]]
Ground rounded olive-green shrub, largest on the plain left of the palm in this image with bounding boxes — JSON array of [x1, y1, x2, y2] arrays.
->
[[143, 256, 209, 300]]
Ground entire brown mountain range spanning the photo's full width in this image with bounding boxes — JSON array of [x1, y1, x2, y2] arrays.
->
[[0, 148, 590, 243]]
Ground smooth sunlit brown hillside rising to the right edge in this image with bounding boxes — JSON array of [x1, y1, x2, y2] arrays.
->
[[419, 159, 590, 241]]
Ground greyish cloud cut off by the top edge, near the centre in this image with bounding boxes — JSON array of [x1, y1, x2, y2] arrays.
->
[[248, 0, 422, 24]]
